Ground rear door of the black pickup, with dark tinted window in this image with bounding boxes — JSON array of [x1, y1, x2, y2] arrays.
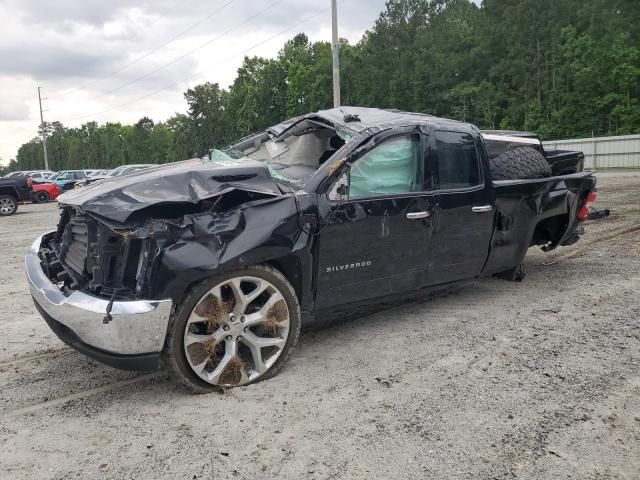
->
[[428, 130, 495, 285]]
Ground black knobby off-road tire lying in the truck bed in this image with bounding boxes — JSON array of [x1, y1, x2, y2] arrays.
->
[[489, 147, 551, 180]]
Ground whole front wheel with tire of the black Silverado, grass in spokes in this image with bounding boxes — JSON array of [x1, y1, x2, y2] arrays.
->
[[168, 265, 300, 394]]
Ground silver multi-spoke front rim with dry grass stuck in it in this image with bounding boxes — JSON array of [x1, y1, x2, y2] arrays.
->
[[184, 276, 291, 387]]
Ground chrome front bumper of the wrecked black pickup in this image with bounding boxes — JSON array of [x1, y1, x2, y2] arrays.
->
[[25, 236, 172, 355]]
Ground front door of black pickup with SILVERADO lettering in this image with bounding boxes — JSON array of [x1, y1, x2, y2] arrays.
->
[[316, 128, 435, 308]]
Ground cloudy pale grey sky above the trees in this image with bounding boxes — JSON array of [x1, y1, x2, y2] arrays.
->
[[0, 0, 385, 164]]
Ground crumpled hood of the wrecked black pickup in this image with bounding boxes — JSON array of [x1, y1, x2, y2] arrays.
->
[[58, 159, 281, 223]]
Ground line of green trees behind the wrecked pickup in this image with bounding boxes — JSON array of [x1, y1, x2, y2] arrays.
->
[[6, 0, 640, 175]]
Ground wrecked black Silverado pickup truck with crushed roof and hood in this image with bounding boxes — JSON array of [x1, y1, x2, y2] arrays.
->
[[26, 107, 596, 392]]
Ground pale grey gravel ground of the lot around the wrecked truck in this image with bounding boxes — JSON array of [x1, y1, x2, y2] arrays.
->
[[0, 173, 640, 480]]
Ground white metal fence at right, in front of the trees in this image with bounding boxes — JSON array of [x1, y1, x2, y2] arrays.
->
[[542, 135, 640, 169]]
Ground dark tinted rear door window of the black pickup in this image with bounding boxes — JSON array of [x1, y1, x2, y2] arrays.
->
[[434, 130, 480, 190]]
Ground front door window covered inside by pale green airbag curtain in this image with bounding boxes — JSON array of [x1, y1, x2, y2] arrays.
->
[[349, 135, 422, 199]]
